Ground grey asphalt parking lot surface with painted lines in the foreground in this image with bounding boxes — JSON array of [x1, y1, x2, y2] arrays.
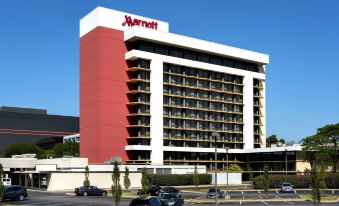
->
[[1, 191, 339, 206]]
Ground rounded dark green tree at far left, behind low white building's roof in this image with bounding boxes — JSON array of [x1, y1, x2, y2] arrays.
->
[[4, 143, 45, 158]]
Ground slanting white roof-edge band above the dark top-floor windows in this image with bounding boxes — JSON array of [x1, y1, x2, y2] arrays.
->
[[124, 27, 269, 64]]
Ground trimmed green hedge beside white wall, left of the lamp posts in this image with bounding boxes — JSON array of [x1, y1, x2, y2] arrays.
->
[[149, 174, 212, 186]]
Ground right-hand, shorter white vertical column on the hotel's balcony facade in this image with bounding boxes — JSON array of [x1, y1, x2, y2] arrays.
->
[[243, 76, 254, 149]]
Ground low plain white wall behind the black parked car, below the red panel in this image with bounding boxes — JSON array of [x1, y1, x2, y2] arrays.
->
[[47, 173, 141, 191]]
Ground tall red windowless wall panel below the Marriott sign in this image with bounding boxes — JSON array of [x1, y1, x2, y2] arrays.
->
[[80, 27, 128, 163]]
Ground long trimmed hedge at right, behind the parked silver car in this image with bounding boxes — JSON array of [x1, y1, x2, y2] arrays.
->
[[253, 173, 339, 189]]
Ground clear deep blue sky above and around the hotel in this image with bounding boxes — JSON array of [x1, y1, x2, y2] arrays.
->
[[0, 0, 339, 140]]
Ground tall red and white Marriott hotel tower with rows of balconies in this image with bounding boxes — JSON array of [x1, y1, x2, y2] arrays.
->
[[80, 7, 269, 169]]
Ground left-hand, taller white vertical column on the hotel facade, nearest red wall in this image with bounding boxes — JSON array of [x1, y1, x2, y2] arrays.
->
[[150, 59, 164, 165]]
